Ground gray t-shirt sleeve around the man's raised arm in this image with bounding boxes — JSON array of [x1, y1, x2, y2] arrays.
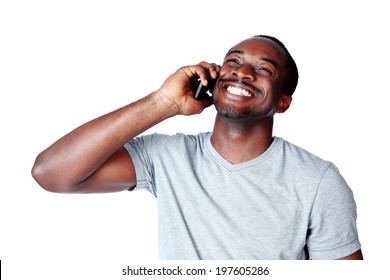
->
[[124, 135, 157, 196]]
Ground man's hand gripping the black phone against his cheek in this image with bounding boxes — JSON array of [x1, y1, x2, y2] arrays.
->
[[156, 62, 221, 115]]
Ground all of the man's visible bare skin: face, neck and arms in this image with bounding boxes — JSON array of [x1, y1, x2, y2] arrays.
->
[[32, 38, 363, 260]]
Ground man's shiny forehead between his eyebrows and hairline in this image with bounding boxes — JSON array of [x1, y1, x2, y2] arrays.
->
[[226, 37, 287, 65]]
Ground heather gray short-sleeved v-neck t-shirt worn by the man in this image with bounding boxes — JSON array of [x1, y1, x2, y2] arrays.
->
[[125, 133, 360, 260]]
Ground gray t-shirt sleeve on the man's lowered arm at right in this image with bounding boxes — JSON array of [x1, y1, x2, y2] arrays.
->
[[307, 164, 360, 260]]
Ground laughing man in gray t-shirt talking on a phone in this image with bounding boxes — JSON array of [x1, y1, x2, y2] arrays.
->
[[32, 36, 362, 259]]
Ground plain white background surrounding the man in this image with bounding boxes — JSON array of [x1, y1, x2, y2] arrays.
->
[[0, 0, 390, 279]]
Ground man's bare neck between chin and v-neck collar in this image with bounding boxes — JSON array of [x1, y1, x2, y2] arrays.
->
[[211, 115, 273, 164]]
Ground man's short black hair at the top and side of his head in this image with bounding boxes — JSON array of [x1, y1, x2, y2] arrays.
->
[[253, 35, 299, 96]]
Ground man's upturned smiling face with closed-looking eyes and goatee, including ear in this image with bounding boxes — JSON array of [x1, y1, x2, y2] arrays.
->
[[213, 38, 291, 119]]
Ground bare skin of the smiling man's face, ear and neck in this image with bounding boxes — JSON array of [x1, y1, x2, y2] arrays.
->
[[212, 39, 292, 163]]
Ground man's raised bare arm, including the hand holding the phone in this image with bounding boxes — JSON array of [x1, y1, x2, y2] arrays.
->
[[32, 62, 219, 193]]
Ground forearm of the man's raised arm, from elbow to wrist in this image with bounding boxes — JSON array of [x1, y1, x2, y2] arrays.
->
[[32, 92, 178, 190]]
